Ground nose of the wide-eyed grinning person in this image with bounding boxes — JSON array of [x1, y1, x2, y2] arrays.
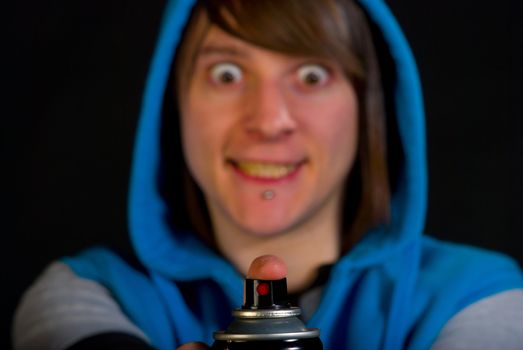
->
[[245, 82, 296, 140]]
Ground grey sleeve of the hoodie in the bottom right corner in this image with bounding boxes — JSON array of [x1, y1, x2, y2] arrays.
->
[[431, 289, 523, 350]]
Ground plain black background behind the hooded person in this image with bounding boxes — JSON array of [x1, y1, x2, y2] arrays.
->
[[4, 0, 523, 348]]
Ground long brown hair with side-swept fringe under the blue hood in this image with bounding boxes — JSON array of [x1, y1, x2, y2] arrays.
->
[[174, 0, 390, 252]]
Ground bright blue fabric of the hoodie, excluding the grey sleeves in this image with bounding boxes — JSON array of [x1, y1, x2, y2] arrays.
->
[[64, 0, 523, 350]]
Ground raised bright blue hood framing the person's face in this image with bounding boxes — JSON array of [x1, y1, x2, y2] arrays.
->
[[129, 0, 427, 300]]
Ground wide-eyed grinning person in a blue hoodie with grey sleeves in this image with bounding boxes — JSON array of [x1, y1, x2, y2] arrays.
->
[[13, 0, 523, 349]]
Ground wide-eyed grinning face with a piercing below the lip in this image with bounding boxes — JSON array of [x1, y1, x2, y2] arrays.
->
[[180, 27, 358, 236]]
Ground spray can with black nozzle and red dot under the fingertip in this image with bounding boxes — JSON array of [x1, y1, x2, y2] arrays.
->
[[211, 278, 323, 350]]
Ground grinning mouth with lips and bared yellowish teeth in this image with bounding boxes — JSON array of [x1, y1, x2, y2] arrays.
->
[[226, 159, 306, 184]]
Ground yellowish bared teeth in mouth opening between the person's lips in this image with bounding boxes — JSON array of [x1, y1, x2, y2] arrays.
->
[[228, 160, 303, 180]]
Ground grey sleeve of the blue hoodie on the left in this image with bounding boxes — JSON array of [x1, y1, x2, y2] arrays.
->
[[13, 262, 149, 350]]
